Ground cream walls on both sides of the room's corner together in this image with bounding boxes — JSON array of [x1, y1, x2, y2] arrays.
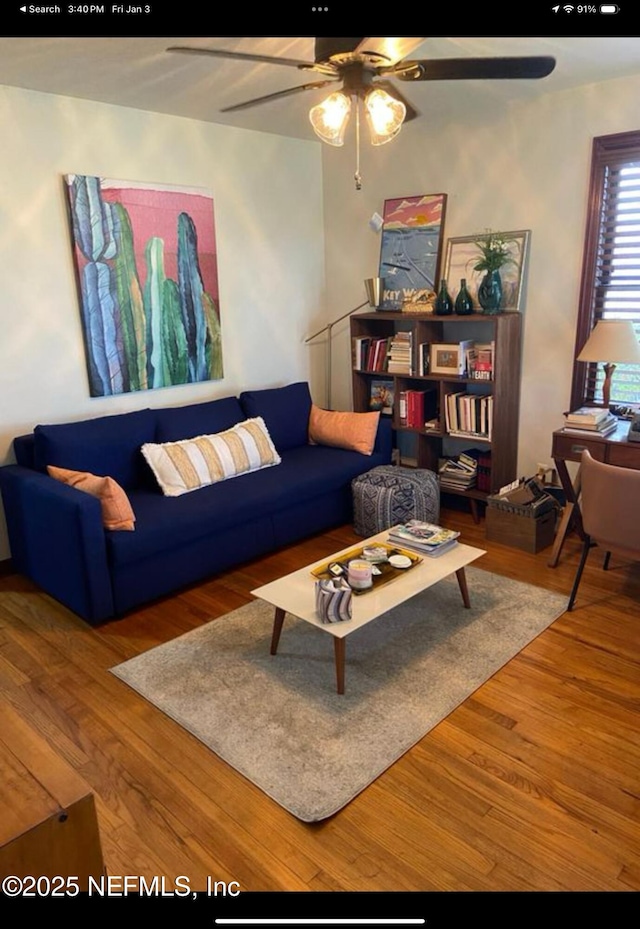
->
[[0, 69, 640, 559]]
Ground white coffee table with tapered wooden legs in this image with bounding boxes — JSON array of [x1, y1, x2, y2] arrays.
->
[[251, 529, 486, 694]]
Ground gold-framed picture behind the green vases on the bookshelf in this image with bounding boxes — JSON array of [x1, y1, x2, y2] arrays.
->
[[442, 229, 531, 313]]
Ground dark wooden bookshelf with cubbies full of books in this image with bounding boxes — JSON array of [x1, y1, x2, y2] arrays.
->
[[351, 311, 522, 501]]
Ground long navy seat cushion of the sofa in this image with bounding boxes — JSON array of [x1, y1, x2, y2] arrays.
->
[[107, 445, 380, 565]]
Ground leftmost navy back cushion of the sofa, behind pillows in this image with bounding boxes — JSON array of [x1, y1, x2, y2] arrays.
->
[[34, 410, 156, 490]]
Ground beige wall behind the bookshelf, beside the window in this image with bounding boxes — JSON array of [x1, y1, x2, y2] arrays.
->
[[323, 71, 640, 474]]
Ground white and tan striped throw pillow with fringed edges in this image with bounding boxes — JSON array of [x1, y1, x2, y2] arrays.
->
[[142, 416, 281, 497]]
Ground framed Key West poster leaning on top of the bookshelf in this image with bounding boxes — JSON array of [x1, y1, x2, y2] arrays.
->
[[379, 194, 447, 312]]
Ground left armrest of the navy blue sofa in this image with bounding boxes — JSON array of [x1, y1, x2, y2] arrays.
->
[[0, 465, 114, 623]]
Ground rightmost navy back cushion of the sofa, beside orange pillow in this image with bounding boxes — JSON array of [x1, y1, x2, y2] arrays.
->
[[240, 381, 311, 452]]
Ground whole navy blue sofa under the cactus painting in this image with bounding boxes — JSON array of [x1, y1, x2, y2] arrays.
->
[[0, 382, 391, 625]]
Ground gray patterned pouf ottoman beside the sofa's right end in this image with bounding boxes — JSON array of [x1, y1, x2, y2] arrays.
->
[[351, 465, 440, 536]]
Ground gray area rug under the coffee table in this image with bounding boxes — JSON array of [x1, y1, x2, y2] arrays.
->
[[111, 568, 567, 822]]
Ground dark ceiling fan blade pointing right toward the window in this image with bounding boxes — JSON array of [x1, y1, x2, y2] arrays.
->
[[396, 55, 556, 81]]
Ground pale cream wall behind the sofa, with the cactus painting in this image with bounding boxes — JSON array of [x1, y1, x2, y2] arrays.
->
[[0, 87, 324, 560]]
